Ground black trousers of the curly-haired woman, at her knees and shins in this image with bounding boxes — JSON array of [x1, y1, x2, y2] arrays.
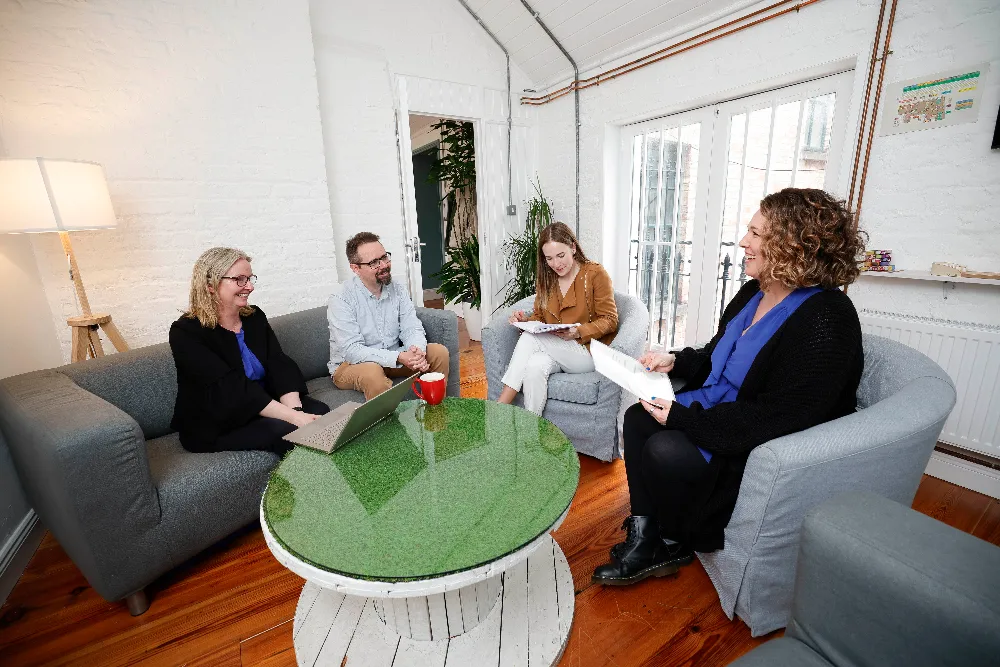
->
[[623, 403, 718, 544]]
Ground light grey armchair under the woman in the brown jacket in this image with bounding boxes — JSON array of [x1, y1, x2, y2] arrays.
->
[[483, 292, 649, 461]]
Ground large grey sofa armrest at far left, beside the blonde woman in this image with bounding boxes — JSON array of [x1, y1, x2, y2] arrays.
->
[[0, 370, 167, 599]]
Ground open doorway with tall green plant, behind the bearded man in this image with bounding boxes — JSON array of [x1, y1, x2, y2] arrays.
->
[[409, 114, 482, 340]]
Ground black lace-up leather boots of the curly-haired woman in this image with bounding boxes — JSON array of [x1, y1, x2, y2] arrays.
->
[[593, 516, 694, 586]]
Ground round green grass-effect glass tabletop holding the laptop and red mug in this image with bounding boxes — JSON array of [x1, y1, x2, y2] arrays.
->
[[263, 398, 580, 581]]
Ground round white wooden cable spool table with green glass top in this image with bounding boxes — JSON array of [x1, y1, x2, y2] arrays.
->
[[260, 398, 579, 667]]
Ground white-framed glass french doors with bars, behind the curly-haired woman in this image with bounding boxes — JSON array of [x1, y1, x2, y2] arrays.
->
[[616, 72, 852, 349]]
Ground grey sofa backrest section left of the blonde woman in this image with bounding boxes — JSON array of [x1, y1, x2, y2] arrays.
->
[[56, 343, 177, 439]]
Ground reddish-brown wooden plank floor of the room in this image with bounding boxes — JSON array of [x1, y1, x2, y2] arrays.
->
[[0, 341, 1000, 667]]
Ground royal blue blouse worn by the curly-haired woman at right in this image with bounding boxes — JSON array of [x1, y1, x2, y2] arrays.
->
[[675, 287, 820, 461]]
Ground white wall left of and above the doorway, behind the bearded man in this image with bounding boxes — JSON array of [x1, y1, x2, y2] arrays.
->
[[310, 0, 530, 280]]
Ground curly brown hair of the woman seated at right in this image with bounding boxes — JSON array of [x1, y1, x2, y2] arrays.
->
[[759, 188, 867, 289]]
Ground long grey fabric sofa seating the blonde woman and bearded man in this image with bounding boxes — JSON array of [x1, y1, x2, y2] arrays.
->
[[0, 307, 460, 613]]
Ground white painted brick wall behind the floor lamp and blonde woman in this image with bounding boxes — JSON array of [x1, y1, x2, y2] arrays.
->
[[0, 0, 337, 360]]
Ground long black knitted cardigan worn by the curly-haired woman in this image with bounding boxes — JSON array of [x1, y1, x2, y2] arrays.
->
[[666, 280, 864, 551]]
